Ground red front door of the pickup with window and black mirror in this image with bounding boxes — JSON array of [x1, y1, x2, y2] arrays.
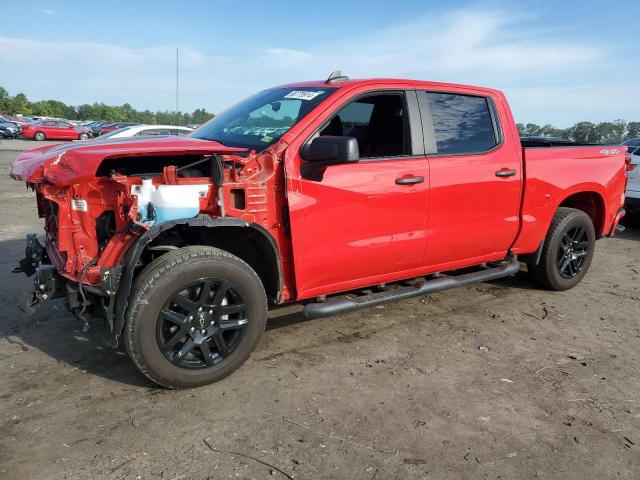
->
[[288, 90, 429, 299]]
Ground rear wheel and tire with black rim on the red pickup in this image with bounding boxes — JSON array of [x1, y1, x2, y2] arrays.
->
[[527, 207, 596, 290]]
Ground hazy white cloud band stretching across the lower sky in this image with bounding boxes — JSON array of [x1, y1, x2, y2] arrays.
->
[[0, 9, 640, 126]]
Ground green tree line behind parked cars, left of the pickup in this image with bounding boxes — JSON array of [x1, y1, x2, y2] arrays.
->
[[0, 87, 214, 125]]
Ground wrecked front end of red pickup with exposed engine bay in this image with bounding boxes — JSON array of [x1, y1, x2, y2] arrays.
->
[[11, 137, 284, 343]]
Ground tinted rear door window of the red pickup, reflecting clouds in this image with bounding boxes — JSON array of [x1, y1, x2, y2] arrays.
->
[[426, 92, 498, 155]]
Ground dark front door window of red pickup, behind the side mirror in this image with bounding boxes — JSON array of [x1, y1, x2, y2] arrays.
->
[[320, 93, 409, 158]]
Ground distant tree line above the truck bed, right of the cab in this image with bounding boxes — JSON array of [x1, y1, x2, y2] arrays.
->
[[518, 120, 640, 143]]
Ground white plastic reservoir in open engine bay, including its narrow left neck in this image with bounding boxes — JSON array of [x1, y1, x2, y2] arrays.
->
[[131, 178, 209, 226]]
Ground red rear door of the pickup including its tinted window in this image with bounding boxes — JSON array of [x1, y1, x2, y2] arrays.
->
[[418, 91, 522, 269]]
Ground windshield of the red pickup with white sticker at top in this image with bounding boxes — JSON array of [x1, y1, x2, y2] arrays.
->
[[189, 87, 336, 151]]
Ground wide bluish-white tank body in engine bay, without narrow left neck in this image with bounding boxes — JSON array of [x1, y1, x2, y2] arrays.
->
[[152, 184, 209, 225]]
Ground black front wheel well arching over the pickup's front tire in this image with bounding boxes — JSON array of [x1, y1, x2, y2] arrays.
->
[[140, 225, 281, 301]]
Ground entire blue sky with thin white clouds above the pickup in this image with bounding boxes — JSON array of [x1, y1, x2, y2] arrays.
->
[[0, 0, 640, 127]]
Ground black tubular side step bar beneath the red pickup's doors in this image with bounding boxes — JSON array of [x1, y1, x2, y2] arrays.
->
[[303, 257, 520, 319]]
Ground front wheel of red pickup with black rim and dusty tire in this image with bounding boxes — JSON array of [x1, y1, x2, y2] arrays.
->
[[124, 246, 267, 388]]
